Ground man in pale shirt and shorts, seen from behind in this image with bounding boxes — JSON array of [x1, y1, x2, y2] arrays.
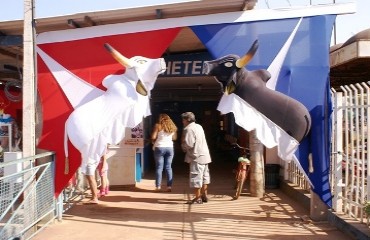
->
[[181, 112, 212, 204]]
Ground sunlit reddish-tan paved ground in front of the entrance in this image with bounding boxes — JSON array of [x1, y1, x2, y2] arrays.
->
[[33, 154, 352, 240]]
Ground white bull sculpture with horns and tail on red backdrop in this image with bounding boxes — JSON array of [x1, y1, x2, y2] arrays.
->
[[64, 44, 166, 174]]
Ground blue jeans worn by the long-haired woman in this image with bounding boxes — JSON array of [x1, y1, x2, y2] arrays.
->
[[154, 147, 174, 187]]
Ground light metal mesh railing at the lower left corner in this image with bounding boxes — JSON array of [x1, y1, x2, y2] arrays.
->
[[0, 152, 62, 240]]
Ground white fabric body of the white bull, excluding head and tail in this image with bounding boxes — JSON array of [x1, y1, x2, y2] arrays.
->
[[66, 75, 139, 173]]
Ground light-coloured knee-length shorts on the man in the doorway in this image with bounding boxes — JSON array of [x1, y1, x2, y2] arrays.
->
[[190, 161, 211, 188]]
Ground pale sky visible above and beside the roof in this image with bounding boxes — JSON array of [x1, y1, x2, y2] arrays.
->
[[0, 0, 370, 45]]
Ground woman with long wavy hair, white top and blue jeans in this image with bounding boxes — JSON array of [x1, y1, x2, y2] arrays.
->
[[151, 113, 177, 192]]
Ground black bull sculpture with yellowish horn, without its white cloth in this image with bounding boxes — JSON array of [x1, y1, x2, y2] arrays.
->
[[203, 40, 311, 142]]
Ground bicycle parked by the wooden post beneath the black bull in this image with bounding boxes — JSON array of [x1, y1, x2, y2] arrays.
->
[[233, 143, 251, 200]]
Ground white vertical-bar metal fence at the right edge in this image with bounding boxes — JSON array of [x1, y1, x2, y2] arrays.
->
[[330, 82, 370, 224]]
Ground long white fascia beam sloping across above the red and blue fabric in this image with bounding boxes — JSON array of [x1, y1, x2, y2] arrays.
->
[[37, 3, 356, 44]]
